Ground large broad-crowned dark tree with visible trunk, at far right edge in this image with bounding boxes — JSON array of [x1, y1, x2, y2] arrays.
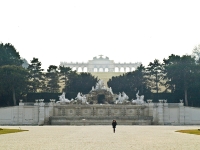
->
[[164, 54, 200, 106]]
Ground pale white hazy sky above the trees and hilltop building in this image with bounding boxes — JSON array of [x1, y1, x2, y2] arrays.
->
[[0, 0, 200, 70]]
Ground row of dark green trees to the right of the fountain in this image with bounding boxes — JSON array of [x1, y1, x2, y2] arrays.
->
[[108, 49, 200, 106]]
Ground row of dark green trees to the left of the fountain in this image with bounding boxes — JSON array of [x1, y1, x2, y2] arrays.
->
[[0, 43, 98, 106]]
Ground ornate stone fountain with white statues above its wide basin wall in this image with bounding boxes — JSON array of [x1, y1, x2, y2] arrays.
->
[[49, 80, 150, 125]]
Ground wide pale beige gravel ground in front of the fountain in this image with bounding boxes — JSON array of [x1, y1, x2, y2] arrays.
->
[[0, 125, 200, 150]]
